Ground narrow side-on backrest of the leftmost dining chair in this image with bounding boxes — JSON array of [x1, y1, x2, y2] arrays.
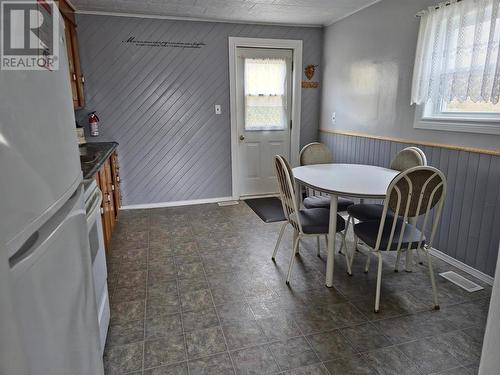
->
[[274, 155, 302, 232]]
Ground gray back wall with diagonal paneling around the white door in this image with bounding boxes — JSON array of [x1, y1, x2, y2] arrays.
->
[[77, 15, 323, 205]]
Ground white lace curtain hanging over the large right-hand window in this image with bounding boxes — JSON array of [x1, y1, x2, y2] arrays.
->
[[411, 0, 500, 104]]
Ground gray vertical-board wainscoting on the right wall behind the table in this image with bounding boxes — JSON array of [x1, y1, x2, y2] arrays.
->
[[320, 132, 500, 276]]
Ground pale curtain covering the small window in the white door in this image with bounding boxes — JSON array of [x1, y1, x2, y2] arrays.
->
[[244, 58, 287, 130]]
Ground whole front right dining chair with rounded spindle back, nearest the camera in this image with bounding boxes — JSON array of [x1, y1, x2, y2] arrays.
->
[[351, 166, 446, 312]]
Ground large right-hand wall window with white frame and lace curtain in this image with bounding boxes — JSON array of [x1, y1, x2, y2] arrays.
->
[[412, 0, 500, 134]]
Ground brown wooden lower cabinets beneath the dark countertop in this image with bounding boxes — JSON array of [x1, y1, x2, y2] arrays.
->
[[95, 151, 121, 251]]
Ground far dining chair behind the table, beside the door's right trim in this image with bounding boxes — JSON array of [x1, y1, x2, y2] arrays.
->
[[299, 142, 354, 212]]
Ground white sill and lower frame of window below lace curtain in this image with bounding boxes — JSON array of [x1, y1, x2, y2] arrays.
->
[[413, 102, 500, 135]]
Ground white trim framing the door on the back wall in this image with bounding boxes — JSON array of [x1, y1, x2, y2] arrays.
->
[[229, 36, 302, 200]]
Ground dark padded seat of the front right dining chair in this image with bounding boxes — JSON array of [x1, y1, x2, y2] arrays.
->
[[354, 219, 425, 251]]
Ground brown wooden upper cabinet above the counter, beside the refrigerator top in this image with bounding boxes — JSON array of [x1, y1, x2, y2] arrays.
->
[[57, 0, 85, 109]]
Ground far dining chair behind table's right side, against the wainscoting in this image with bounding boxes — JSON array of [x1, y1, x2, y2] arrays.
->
[[345, 147, 427, 272]]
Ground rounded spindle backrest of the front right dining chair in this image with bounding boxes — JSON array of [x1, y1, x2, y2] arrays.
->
[[376, 166, 447, 250]]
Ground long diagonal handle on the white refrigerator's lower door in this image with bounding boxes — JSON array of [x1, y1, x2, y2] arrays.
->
[[9, 185, 83, 269]]
